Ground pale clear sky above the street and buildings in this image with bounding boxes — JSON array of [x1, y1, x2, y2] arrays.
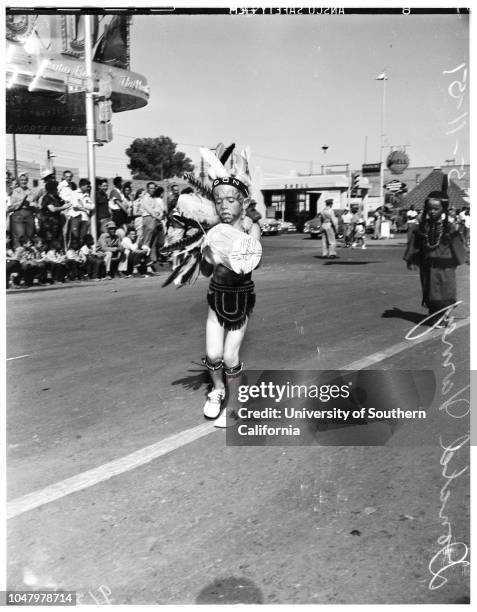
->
[[7, 6, 469, 178]]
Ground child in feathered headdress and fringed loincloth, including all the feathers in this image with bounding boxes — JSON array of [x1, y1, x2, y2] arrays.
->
[[163, 144, 262, 427]]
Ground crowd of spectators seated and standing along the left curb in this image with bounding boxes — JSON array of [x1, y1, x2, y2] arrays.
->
[[6, 170, 179, 288]]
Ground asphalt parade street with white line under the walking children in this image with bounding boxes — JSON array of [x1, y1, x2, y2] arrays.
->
[[6, 234, 469, 604]]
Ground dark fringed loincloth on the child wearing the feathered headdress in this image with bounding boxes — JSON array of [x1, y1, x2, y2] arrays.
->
[[207, 280, 255, 331]]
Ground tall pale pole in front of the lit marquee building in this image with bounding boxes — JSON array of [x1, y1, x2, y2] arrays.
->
[[84, 14, 97, 244]]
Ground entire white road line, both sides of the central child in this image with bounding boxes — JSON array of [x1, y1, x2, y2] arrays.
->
[[7, 319, 470, 519]]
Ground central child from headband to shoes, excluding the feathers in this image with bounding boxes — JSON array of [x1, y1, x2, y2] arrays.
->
[[201, 167, 261, 427]]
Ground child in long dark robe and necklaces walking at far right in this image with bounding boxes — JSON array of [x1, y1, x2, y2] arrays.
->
[[403, 175, 466, 327]]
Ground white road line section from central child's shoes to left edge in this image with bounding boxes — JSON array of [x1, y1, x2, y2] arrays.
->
[[7, 423, 217, 519]]
